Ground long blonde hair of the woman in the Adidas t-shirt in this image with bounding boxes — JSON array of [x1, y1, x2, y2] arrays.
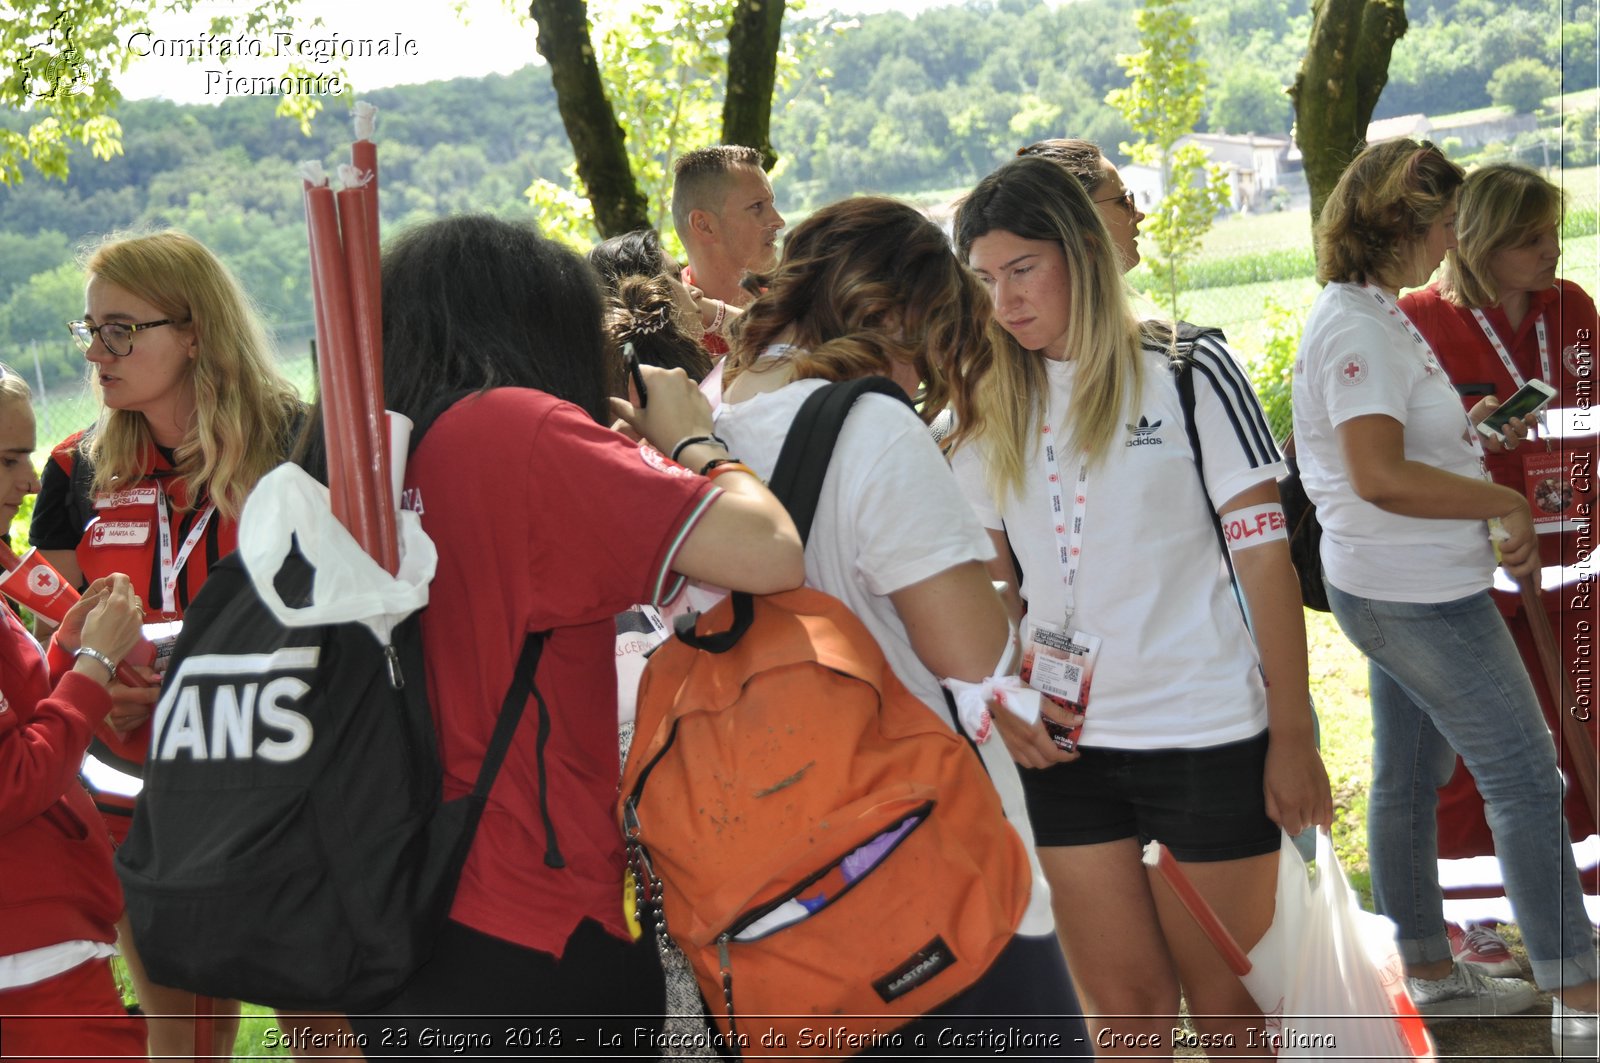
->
[[950, 157, 1142, 504]]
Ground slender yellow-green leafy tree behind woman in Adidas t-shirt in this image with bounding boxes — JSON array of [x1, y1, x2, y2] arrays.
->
[[1106, 0, 1227, 317]]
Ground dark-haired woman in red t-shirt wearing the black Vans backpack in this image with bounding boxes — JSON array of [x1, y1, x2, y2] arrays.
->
[[348, 216, 802, 1055]]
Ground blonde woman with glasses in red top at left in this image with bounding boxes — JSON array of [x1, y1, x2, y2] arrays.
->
[[30, 232, 301, 1057]]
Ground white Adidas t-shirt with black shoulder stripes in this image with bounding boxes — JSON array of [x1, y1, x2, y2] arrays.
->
[[952, 338, 1283, 749]]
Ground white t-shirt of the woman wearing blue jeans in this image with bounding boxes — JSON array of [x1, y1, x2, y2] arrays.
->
[[1294, 283, 1494, 602]]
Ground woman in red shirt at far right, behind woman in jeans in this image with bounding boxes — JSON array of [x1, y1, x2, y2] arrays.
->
[[1400, 163, 1600, 973]]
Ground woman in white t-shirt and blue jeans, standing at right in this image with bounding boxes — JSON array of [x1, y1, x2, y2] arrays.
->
[[1294, 139, 1595, 1057]]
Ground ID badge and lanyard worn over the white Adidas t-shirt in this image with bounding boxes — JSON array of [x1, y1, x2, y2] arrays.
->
[[1022, 424, 1101, 752]]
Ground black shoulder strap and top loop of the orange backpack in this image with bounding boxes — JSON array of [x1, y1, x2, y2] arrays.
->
[[674, 376, 910, 653]]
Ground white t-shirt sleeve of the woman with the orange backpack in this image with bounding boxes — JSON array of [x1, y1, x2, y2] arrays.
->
[[835, 395, 994, 596]]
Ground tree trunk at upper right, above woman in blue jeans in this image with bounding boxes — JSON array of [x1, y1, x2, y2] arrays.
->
[[1290, 0, 1406, 226]]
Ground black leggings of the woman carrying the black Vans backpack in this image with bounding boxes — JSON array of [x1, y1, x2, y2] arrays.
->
[[350, 919, 667, 1060]]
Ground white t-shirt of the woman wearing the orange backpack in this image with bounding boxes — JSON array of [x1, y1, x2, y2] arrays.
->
[[715, 379, 1054, 935]]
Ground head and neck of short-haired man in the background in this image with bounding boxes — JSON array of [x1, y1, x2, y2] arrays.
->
[[672, 144, 784, 346]]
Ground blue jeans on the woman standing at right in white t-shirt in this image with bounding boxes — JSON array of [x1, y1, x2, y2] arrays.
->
[[1328, 584, 1595, 989]]
